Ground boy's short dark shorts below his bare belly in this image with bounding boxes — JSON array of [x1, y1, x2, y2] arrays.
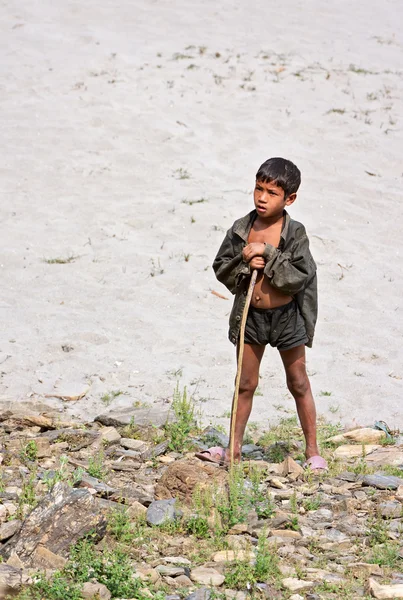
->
[[245, 300, 308, 352]]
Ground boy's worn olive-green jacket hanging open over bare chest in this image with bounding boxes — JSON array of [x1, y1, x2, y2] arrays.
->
[[213, 210, 318, 347]]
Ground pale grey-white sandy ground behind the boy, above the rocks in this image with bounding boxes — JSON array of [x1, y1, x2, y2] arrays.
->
[[0, 0, 403, 428]]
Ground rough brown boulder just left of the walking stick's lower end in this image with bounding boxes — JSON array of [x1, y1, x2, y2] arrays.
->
[[155, 458, 228, 502]]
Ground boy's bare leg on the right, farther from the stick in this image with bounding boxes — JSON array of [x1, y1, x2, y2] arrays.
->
[[280, 346, 319, 458]]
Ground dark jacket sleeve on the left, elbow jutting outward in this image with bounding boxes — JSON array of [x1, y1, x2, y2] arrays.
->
[[213, 228, 250, 294]]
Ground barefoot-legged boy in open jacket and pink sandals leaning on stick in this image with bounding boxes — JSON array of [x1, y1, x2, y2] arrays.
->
[[197, 158, 327, 472]]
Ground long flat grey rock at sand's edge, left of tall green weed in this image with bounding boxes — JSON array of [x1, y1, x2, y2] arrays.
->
[[95, 405, 173, 427]]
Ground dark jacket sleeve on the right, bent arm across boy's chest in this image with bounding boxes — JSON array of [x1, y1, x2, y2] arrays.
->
[[263, 229, 316, 296]]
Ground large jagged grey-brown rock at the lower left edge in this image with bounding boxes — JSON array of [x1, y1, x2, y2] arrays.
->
[[0, 483, 106, 566]]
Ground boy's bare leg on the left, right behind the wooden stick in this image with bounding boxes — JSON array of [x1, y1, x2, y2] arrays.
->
[[226, 344, 265, 461]]
